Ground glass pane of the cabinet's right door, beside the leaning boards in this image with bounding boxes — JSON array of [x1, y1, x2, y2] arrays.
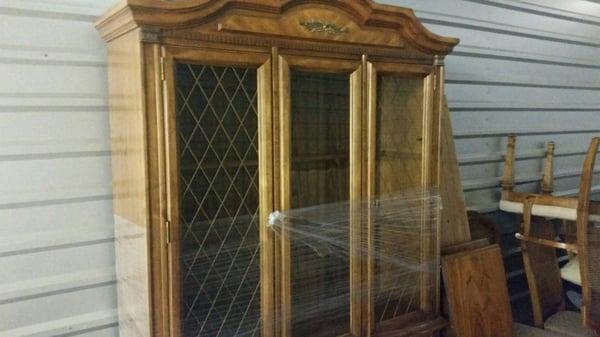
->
[[374, 75, 423, 322]]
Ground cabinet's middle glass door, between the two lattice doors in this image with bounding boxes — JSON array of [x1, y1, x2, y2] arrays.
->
[[281, 58, 360, 337]]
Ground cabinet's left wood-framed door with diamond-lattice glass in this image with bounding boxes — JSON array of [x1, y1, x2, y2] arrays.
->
[[165, 49, 271, 337]]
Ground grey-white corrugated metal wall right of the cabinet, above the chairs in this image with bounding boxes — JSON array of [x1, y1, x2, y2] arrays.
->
[[385, 0, 600, 211]]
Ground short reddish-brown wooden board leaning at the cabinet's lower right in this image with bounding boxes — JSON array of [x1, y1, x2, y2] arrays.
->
[[442, 245, 515, 337]]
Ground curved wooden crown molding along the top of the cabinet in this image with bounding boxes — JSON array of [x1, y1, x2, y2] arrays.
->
[[96, 0, 459, 56]]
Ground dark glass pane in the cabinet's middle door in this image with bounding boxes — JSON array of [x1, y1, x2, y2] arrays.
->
[[291, 71, 350, 337]]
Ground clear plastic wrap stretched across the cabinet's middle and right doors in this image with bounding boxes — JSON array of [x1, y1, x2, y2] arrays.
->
[[265, 191, 441, 336]]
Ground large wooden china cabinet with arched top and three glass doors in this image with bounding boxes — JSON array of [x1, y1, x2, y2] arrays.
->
[[97, 0, 458, 337]]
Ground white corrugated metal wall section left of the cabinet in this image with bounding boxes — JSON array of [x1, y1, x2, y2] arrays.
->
[[0, 0, 118, 337]]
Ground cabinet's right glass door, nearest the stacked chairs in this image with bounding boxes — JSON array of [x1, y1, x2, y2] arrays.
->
[[369, 63, 437, 329]]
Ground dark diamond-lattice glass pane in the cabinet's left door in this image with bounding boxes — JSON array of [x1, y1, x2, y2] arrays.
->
[[176, 64, 260, 337]]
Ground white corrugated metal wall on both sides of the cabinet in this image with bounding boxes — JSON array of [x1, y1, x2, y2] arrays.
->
[[0, 0, 600, 337]]
